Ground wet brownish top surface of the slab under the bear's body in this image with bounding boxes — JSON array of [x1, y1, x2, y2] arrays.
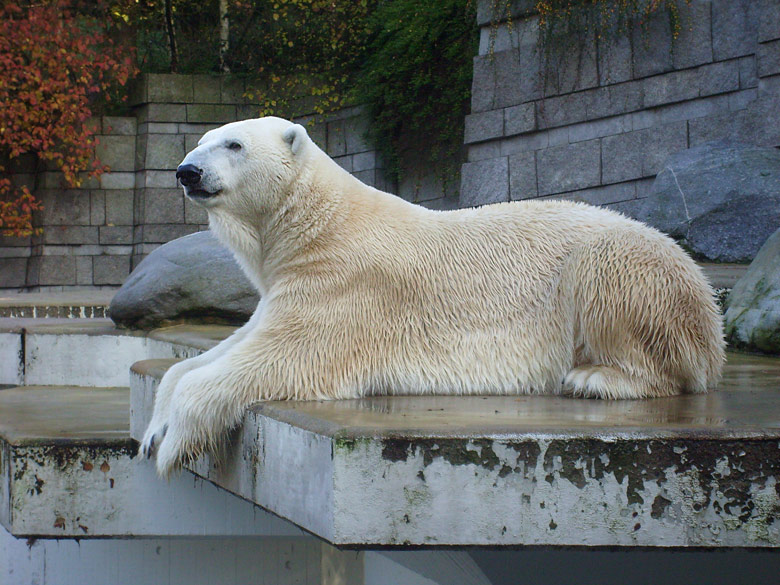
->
[[254, 353, 780, 437]]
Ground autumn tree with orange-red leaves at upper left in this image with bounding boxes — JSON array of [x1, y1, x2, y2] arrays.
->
[[0, 0, 136, 236]]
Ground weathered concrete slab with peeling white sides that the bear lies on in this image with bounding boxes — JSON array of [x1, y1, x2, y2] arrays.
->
[[131, 354, 780, 547]]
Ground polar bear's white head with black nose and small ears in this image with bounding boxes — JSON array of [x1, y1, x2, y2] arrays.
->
[[176, 117, 313, 216]]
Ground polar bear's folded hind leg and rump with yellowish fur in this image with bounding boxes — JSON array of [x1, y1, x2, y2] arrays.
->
[[562, 226, 724, 399]]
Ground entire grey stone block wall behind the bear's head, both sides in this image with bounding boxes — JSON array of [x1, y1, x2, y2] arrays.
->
[[0, 75, 392, 290]]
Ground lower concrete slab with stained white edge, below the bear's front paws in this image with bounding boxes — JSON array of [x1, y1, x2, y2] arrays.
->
[[0, 386, 302, 538]]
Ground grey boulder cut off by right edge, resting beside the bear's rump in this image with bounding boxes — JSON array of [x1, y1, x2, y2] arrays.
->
[[725, 230, 780, 354]]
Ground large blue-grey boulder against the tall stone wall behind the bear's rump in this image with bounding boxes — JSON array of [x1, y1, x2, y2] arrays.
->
[[635, 142, 780, 262]]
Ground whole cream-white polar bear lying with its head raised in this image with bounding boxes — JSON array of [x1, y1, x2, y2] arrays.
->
[[142, 117, 724, 476]]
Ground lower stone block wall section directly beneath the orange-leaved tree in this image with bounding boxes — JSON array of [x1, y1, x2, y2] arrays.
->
[[0, 117, 137, 289]]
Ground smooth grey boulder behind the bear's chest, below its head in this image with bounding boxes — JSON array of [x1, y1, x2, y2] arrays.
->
[[109, 232, 259, 329]]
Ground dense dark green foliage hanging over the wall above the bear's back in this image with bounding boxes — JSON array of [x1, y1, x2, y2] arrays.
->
[[352, 0, 478, 187]]
